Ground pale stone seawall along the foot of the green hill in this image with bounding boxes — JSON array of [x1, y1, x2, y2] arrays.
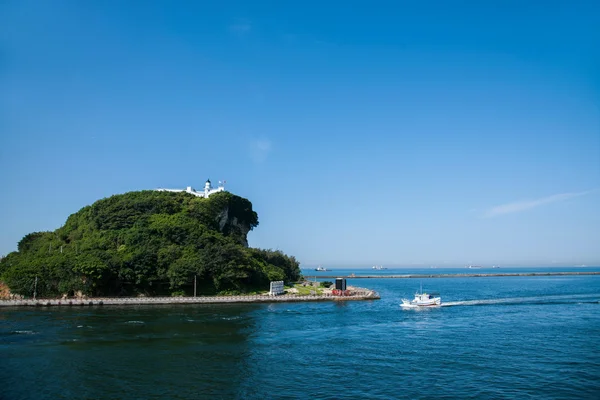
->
[[0, 291, 380, 307]]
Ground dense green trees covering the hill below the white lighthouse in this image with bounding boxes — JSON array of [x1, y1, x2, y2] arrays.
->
[[0, 191, 300, 297]]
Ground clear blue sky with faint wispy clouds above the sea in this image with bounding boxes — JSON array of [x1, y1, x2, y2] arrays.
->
[[0, 0, 600, 267]]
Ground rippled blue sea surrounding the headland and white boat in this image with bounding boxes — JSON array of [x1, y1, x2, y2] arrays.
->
[[0, 267, 600, 400]]
